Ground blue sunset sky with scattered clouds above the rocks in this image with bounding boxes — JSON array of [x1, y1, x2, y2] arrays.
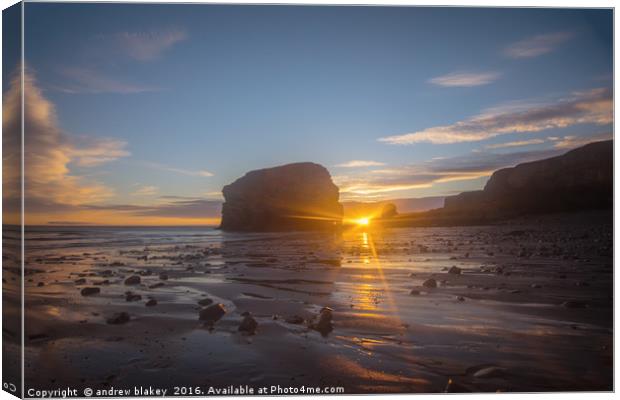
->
[[3, 3, 613, 225]]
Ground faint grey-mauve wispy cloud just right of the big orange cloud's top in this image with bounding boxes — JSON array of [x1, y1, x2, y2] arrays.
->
[[52, 67, 159, 94]]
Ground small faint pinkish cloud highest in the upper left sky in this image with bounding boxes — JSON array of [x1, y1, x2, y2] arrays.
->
[[98, 28, 188, 61]]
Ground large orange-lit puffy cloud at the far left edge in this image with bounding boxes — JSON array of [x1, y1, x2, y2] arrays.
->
[[2, 70, 129, 222]]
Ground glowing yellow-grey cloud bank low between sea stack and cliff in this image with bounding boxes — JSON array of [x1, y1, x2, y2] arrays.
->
[[334, 149, 564, 199]]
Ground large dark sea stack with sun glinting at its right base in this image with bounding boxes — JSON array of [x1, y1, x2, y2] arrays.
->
[[220, 162, 342, 232]]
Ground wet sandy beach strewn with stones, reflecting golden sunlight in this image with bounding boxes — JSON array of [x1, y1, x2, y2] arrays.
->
[[4, 213, 613, 393]]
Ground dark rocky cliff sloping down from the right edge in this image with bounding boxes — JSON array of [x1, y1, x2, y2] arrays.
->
[[440, 140, 613, 220]]
